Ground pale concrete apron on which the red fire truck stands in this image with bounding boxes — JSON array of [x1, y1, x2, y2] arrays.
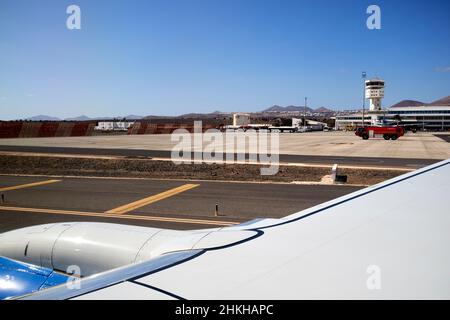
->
[[0, 131, 450, 161]]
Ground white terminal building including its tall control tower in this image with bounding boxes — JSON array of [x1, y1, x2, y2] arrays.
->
[[335, 79, 450, 131]]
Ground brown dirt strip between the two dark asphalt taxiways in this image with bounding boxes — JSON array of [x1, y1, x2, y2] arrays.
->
[[0, 155, 405, 185]]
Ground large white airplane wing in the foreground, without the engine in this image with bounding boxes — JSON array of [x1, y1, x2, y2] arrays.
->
[[15, 160, 450, 299]]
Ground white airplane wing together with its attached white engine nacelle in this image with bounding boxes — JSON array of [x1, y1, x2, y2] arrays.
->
[[0, 160, 450, 299]]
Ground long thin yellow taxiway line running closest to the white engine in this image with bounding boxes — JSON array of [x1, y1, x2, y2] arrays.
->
[[0, 206, 239, 226]]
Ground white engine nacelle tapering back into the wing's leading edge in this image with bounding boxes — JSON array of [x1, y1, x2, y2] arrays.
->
[[0, 222, 255, 276]]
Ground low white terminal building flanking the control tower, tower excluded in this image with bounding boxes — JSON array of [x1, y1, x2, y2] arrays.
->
[[335, 105, 450, 131]]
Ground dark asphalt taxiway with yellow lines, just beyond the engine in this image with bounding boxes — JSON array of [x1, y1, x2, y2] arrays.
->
[[0, 176, 360, 233]]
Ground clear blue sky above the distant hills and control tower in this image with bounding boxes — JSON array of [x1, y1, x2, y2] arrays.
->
[[0, 0, 450, 119]]
